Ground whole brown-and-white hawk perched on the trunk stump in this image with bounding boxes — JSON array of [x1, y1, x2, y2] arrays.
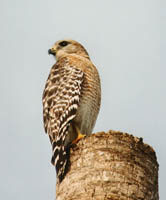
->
[[43, 40, 101, 182]]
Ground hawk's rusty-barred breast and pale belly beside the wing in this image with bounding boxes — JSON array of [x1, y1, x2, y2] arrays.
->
[[74, 66, 101, 135]]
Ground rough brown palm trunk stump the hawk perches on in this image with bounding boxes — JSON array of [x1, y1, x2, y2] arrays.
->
[[56, 131, 159, 200]]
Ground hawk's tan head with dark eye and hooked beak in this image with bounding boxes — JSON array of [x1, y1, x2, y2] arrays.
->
[[48, 40, 89, 59]]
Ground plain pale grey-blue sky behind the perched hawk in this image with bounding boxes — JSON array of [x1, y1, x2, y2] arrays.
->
[[0, 0, 166, 200]]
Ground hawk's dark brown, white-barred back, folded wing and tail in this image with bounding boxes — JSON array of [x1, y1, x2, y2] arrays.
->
[[43, 57, 84, 179]]
